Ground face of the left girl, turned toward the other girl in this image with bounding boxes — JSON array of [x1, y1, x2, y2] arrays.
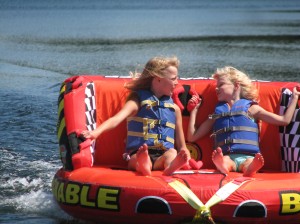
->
[[159, 66, 178, 96]]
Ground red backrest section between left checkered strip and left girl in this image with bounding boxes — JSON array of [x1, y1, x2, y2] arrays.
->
[[95, 78, 128, 168]]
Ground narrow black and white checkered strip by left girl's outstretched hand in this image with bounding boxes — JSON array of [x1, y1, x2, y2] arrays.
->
[[84, 82, 97, 157]]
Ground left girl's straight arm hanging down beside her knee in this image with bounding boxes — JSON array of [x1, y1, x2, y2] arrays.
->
[[174, 104, 191, 159]]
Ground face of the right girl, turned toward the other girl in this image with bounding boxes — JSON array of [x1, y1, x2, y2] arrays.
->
[[216, 76, 235, 102]]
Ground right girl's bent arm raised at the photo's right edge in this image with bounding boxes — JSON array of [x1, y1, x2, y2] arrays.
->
[[249, 87, 300, 126]]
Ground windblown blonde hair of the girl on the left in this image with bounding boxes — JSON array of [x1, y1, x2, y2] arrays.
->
[[124, 56, 179, 91]]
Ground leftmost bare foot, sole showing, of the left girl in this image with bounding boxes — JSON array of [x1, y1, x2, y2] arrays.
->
[[136, 144, 151, 176]]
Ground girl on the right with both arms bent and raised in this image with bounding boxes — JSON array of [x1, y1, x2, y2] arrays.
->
[[187, 66, 300, 176]]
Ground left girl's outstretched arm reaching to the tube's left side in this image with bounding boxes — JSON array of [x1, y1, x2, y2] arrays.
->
[[82, 100, 139, 139]]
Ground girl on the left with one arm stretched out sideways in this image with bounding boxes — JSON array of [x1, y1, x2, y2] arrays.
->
[[82, 57, 190, 175]]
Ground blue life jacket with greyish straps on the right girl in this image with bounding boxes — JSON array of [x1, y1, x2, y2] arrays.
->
[[210, 99, 260, 155]]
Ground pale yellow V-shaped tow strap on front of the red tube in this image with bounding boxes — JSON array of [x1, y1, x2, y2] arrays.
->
[[168, 177, 253, 224]]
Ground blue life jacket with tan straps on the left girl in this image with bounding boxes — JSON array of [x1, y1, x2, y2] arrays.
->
[[126, 90, 176, 151]]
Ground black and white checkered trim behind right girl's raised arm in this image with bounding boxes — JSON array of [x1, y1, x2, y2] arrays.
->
[[279, 88, 300, 173]]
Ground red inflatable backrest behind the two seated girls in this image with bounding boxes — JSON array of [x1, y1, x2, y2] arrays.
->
[[60, 76, 299, 171]]
